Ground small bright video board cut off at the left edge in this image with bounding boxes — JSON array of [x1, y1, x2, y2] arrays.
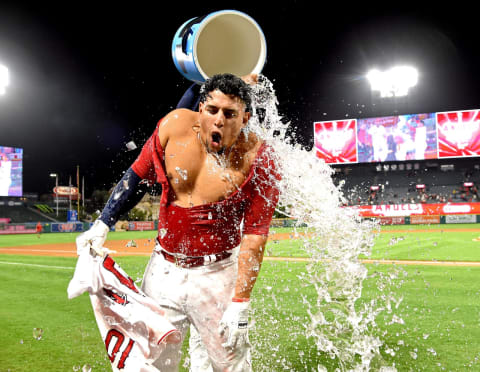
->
[[0, 146, 23, 196]]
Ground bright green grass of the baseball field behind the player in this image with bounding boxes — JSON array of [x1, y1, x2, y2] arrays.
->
[[0, 225, 480, 372]]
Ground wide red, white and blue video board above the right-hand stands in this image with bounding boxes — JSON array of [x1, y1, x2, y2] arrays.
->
[[314, 110, 480, 163]]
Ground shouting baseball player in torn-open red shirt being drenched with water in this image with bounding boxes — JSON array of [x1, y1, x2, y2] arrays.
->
[[77, 74, 279, 371]]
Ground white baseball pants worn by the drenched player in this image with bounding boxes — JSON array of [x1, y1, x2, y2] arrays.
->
[[142, 247, 252, 372]]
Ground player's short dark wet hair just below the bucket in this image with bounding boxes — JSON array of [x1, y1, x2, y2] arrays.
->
[[200, 74, 252, 112]]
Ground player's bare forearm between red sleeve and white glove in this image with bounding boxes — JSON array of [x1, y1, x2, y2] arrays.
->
[[234, 235, 267, 299]]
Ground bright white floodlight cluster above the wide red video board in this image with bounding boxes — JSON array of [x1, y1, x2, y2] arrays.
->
[[367, 66, 418, 98]]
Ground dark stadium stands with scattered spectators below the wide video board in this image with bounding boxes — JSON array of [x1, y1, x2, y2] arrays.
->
[[333, 160, 480, 206]]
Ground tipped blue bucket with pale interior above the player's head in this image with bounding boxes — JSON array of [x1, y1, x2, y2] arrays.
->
[[172, 10, 267, 84]]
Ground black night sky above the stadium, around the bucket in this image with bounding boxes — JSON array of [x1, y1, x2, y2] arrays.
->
[[0, 1, 480, 197]]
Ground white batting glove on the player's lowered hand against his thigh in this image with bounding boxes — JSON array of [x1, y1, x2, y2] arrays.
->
[[219, 300, 250, 350]]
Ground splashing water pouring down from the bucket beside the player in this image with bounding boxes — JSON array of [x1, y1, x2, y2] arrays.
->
[[248, 75, 401, 371]]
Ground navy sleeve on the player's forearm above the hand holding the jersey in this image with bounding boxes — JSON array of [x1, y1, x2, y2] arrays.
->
[[99, 168, 148, 227]]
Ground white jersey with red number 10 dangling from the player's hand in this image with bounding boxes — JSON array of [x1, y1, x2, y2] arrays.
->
[[68, 252, 181, 372]]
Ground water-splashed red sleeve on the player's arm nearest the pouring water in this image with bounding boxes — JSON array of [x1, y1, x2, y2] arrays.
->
[[243, 145, 281, 235]]
